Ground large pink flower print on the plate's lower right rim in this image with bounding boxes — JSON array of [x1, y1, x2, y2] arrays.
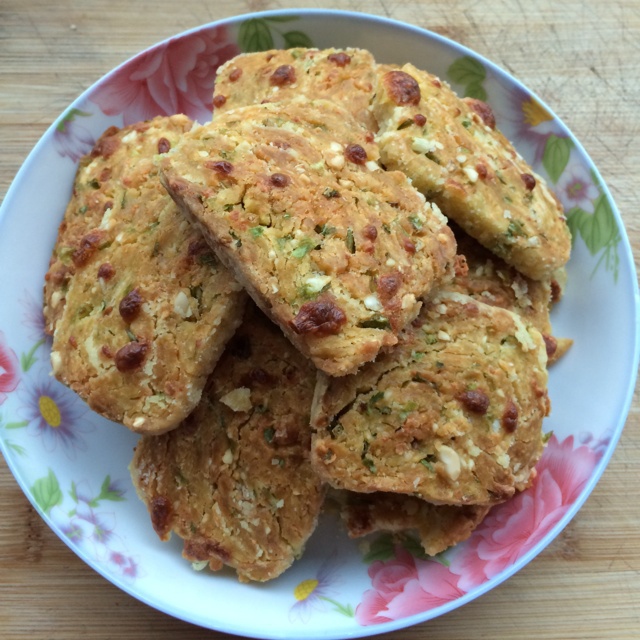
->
[[356, 436, 602, 625]]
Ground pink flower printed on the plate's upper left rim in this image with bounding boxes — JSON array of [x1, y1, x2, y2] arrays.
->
[[91, 26, 240, 125]]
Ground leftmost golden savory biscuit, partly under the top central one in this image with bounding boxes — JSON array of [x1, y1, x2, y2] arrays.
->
[[44, 116, 246, 433]]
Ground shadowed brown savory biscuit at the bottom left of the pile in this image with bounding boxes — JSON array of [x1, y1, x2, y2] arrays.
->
[[130, 305, 324, 581]]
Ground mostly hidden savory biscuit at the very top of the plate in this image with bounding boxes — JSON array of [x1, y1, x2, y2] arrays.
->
[[213, 48, 377, 131]]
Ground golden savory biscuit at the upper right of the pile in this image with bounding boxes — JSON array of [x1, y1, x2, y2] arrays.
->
[[372, 64, 571, 280]]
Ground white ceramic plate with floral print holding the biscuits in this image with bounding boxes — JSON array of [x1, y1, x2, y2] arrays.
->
[[0, 11, 638, 639]]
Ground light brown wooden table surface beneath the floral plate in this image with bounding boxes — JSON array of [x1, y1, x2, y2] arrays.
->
[[0, 0, 640, 640]]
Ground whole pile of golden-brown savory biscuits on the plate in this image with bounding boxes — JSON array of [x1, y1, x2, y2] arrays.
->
[[44, 49, 571, 581]]
